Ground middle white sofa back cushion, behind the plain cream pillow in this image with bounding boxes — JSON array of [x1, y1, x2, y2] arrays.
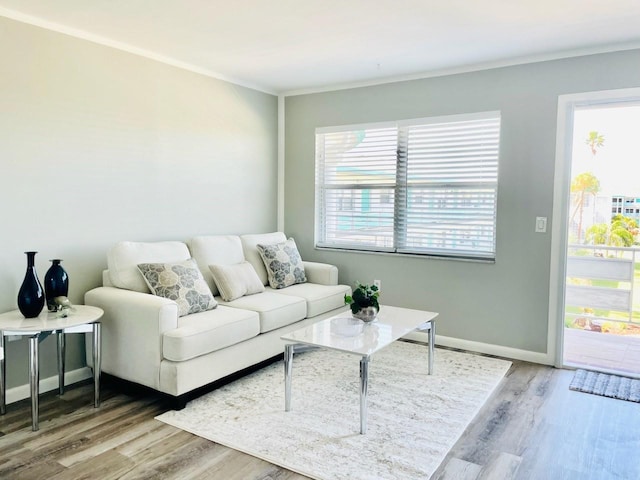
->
[[188, 235, 244, 295]]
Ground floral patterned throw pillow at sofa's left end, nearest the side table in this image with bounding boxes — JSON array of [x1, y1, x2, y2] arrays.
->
[[138, 259, 218, 317]]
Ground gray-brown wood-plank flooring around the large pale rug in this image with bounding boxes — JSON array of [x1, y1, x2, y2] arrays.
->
[[0, 352, 640, 480]]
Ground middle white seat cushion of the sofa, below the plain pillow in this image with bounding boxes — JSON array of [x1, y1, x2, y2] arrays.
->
[[216, 292, 307, 333]]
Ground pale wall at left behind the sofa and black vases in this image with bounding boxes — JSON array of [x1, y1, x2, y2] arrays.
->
[[0, 18, 277, 388]]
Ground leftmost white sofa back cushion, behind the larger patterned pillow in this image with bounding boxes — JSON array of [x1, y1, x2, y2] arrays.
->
[[107, 241, 191, 293]]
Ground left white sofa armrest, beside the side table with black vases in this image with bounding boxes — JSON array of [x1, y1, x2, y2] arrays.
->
[[84, 287, 178, 390]]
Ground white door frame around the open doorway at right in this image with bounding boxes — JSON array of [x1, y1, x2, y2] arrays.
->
[[547, 88, 640, 368]]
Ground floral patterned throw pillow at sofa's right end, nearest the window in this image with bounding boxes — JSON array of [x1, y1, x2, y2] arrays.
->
[[257, 238, 307, 288]]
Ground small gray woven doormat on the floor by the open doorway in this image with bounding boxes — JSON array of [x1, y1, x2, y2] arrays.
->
[[569, 369, 640, 402]]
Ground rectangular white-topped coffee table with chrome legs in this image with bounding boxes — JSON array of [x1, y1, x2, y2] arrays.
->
[[281, 305, 438, 434]]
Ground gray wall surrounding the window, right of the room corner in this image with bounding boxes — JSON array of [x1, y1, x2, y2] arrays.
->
[[285, 50, 640, 353]]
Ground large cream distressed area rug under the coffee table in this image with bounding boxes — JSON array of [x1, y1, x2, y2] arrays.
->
[[156, 342, 511, 480]]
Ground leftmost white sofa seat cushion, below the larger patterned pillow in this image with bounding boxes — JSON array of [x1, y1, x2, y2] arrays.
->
[[162, 305, 260, 362]]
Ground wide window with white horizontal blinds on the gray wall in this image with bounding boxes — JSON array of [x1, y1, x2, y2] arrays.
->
[[316, 112, 500, 259]]
